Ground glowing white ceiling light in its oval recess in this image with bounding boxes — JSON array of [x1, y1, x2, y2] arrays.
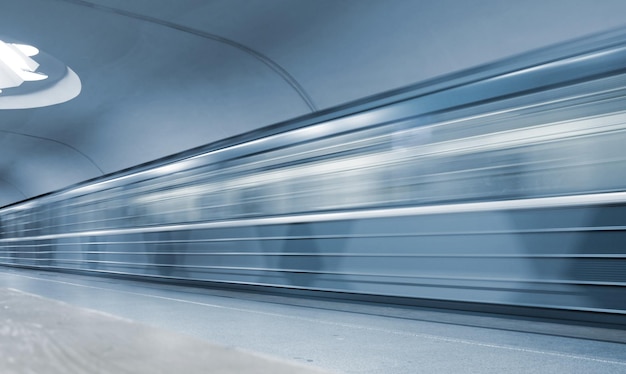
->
[[0, 40, 81, 109]]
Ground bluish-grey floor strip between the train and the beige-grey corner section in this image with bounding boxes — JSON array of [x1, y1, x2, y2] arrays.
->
[[0, 268, 626, 374]]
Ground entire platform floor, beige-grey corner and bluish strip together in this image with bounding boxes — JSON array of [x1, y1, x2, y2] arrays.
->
[[0, 268, 626, 374]]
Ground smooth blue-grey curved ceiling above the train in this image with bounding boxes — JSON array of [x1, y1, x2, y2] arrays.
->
[[0, 0, 626, 206]]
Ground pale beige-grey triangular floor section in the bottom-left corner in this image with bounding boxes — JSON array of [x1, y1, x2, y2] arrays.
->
[[0, 288, 322, 374]]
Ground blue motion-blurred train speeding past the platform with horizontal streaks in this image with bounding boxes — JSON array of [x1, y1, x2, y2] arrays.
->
[[0, 31, 626, 317]]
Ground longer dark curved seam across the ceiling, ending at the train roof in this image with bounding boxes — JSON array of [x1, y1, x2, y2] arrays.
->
[[57, 0, 319, 112]]
